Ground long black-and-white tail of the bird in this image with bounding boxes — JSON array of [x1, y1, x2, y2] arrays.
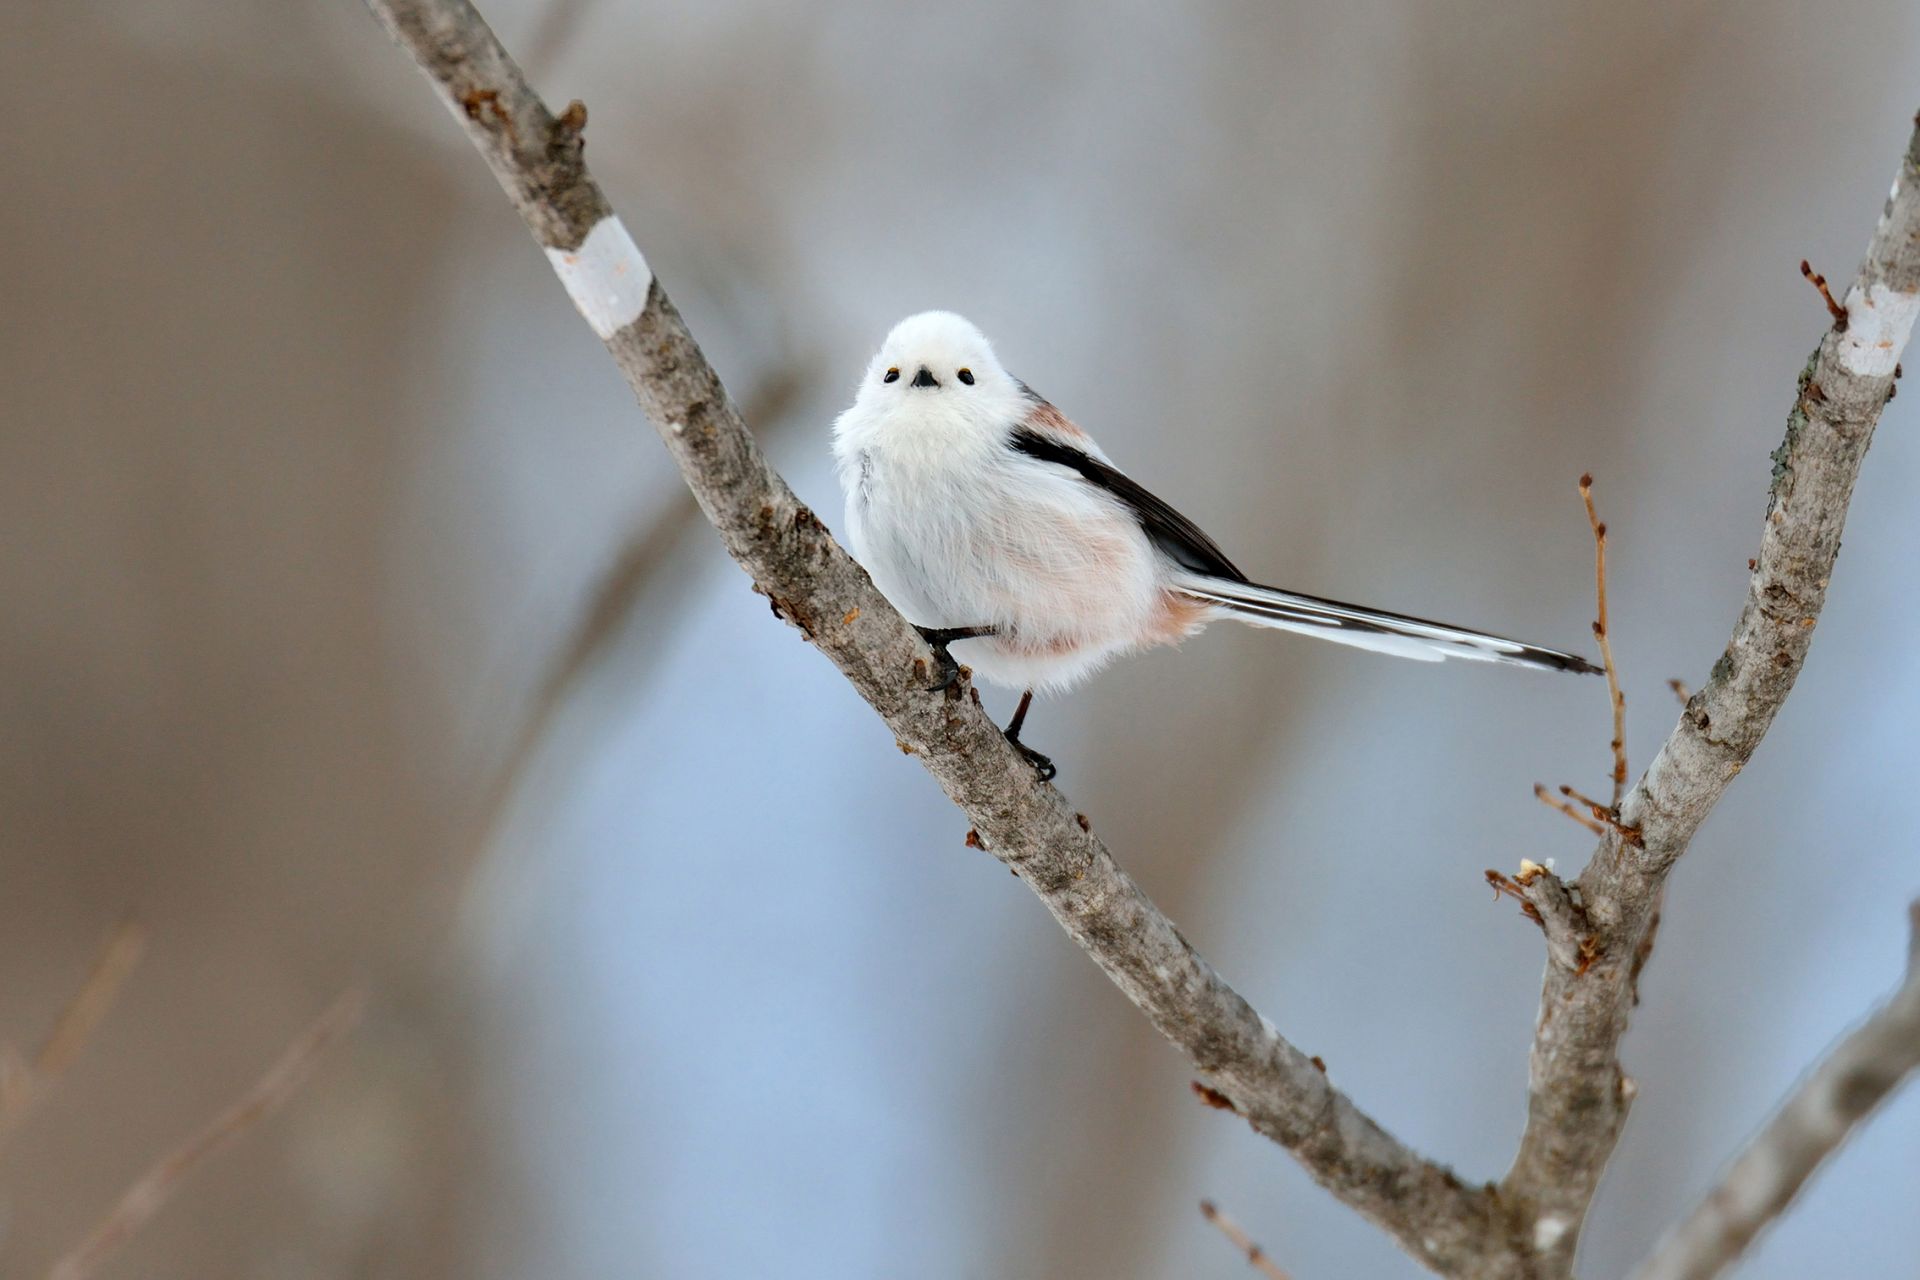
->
[[1179, 574, 1601, 676]]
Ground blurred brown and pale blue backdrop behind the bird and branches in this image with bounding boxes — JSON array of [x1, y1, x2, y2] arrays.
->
[[0, 0, 1920, 1280]]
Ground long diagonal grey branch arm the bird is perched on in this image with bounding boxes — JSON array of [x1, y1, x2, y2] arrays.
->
[[369, 0, 1513, 1276]]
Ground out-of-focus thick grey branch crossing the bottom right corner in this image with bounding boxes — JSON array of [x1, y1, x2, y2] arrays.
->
[[1634, 902, 1920, 1280]]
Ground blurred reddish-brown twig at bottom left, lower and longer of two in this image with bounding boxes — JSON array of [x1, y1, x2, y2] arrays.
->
[[46, 990, 365, 1280]]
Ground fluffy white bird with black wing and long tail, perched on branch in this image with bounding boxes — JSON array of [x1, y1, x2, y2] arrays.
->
[[833, 311, 1601, 779]]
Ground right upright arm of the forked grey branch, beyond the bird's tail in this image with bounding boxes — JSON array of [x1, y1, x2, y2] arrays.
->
[[1501, 117, 1920, 1274]]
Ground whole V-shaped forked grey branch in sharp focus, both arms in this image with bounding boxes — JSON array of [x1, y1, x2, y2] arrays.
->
[[357, 0, 1920, 1276]]
